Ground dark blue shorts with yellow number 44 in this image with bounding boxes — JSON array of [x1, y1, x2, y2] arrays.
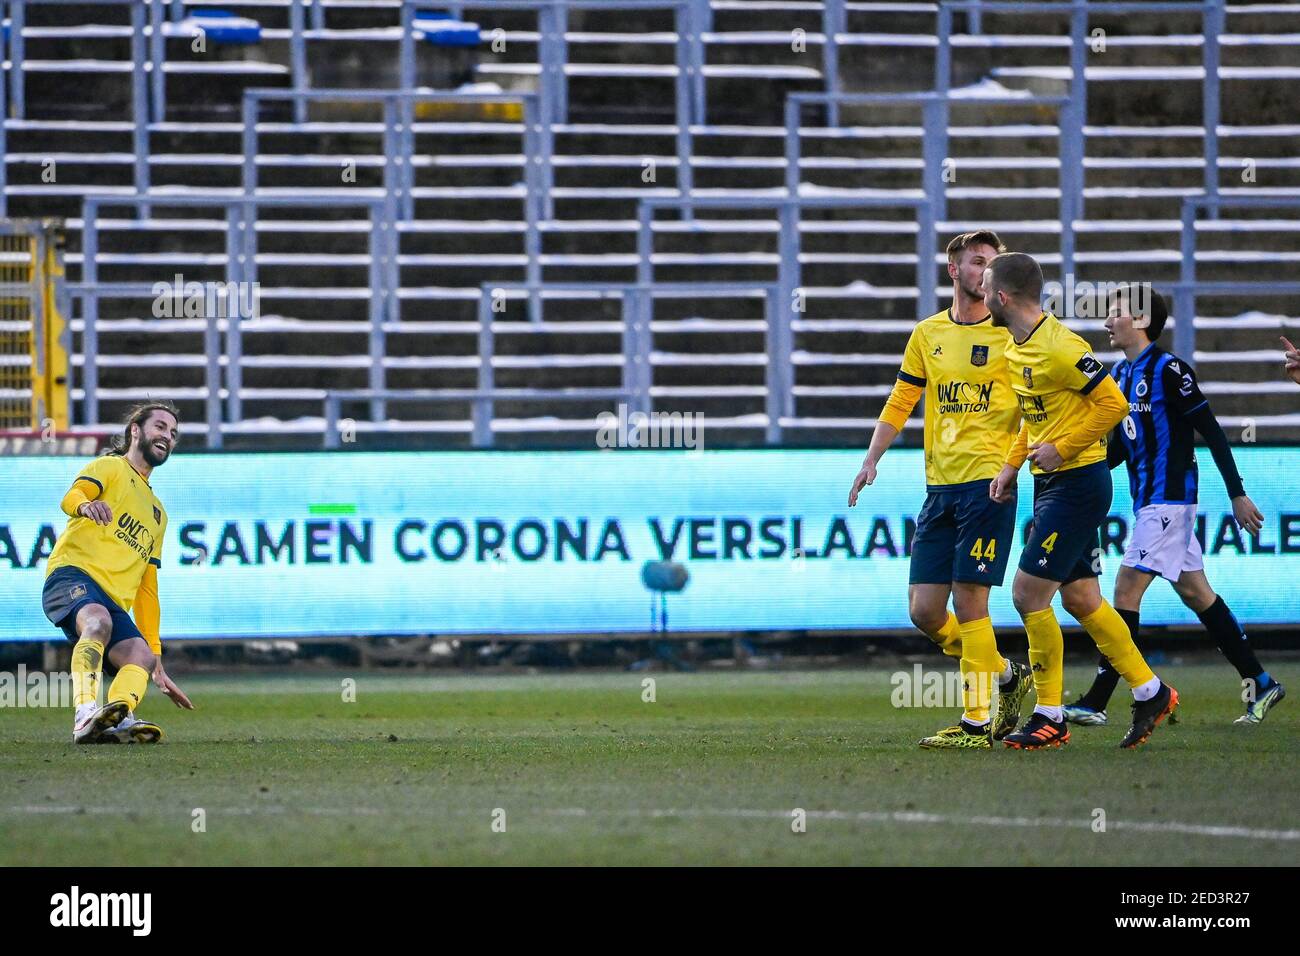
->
[[909, 479, 1015, 587]]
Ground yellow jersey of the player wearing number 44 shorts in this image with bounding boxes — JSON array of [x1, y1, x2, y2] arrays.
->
[[880, 308, 1021, 489]]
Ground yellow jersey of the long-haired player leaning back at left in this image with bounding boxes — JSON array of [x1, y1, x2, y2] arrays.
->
[[46, 455, 166, 611]]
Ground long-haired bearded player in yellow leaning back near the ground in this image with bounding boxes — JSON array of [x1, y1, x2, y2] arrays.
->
[[42, 402, 194, 744]]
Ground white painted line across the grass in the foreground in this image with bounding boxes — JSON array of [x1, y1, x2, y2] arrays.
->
[[10, 804, 1300, 840]]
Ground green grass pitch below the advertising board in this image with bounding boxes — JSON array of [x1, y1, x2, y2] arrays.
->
[[0, 661, 1300, 866]]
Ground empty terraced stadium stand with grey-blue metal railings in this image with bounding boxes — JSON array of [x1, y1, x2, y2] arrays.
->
[[0, 0, 1300, 446]]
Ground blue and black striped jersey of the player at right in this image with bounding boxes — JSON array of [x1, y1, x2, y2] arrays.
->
[[1112, 343, 1209, 511]]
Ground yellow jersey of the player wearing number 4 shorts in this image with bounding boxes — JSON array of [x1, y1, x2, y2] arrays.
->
[[1006, 312, 1106, 475]]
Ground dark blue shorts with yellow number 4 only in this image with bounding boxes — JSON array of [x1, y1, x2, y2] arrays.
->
[[1021, 462, 1112, 584]]
